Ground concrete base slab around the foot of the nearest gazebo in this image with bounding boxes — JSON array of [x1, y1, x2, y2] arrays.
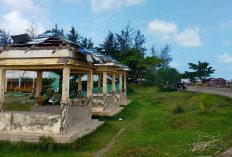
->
[[0, 119, 104, 143]]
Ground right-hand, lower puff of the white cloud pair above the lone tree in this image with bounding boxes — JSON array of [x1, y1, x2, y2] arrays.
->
[[174, 27, 202, 47]]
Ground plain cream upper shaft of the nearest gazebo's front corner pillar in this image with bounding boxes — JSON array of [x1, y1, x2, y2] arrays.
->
[[61, 66, 70, 103]]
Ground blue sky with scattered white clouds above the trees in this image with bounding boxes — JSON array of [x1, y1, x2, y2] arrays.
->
[[0, 0, 232, 80]]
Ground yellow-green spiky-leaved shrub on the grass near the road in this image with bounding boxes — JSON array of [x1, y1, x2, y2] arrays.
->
[[199, 93, 213, 112]]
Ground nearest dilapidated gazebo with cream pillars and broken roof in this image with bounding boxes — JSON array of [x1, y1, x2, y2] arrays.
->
[[0, 31, 103, 142]]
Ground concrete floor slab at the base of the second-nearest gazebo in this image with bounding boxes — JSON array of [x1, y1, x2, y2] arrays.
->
[[92, 105, 123, 117]]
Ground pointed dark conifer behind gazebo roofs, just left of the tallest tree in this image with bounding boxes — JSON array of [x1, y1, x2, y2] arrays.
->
[[100, 31, 118, 59]]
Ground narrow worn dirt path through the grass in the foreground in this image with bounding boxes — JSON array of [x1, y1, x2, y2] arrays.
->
[[94, 127, 126, 157]]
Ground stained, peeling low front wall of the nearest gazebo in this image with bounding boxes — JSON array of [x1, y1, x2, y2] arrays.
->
[[0, 112, 61, 134]]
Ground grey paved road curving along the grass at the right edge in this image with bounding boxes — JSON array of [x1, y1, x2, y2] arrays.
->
[[187, 86, 232, 98]]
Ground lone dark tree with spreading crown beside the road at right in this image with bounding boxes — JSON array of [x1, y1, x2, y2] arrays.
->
[[189, 61, 215, 80]]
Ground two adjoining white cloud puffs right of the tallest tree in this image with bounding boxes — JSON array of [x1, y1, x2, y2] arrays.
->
[[147, 20, 202, 47]]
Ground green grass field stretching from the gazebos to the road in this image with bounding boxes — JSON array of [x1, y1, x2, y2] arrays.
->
[[0, 87, 232, 157]]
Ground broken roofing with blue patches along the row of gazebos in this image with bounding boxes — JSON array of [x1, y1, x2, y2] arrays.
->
[[0, 31, 129, 71]]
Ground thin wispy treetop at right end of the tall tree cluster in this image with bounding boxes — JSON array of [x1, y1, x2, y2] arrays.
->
[[159, 45, 172, 68]]
